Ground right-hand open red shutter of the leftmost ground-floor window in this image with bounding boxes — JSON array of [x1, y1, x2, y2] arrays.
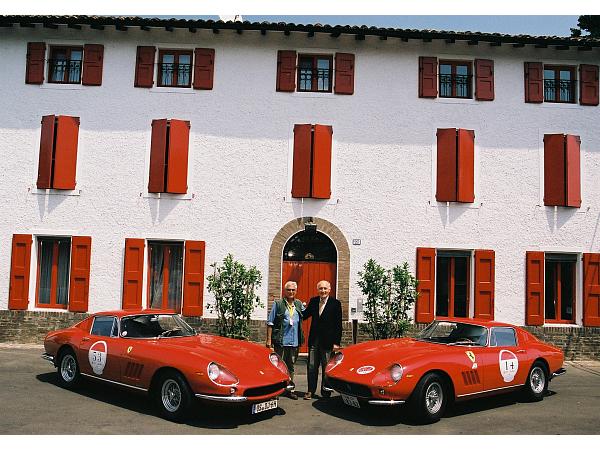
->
[[69, 236, 92, 312]]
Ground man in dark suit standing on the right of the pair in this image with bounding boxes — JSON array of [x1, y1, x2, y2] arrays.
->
[[302, 280, 342, 400]]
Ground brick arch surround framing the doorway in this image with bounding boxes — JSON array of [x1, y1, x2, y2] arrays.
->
[[267, 217, 350, 320]]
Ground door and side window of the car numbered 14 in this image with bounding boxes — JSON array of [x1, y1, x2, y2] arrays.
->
[[484, 327, 529, 391]]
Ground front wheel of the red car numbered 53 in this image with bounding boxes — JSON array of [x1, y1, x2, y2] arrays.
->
[[154, 371, 193, 422]]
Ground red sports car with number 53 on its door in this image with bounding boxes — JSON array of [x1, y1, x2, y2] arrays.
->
[[43, 311, 291, 421]]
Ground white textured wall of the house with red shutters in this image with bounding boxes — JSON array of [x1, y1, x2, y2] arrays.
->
[[0, 27, 600, 324]]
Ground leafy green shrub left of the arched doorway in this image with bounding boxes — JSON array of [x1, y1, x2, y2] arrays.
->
[[206, 254, 262, 339]]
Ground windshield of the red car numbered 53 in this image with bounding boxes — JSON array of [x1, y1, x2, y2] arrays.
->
[[121, 314, 196, 338]]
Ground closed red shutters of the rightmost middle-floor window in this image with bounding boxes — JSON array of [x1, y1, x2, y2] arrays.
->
[[544, 134, 581, 208]]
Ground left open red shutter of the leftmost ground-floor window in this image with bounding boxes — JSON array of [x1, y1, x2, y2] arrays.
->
[[8, 234, 32, 310]]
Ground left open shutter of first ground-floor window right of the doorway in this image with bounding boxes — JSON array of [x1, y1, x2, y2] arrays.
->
[[415, 247, 435, 323]]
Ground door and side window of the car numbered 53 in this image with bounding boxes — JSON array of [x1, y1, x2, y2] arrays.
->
[[78, 316, 124, 382]]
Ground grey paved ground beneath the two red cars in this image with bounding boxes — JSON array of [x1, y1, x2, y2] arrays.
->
[[0, 344, 600, 435]]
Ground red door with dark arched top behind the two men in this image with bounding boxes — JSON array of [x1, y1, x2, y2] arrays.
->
[[281, 228, 337, 352]]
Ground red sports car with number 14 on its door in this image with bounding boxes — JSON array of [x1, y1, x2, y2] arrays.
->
[[326, 319, 566, 423]]
